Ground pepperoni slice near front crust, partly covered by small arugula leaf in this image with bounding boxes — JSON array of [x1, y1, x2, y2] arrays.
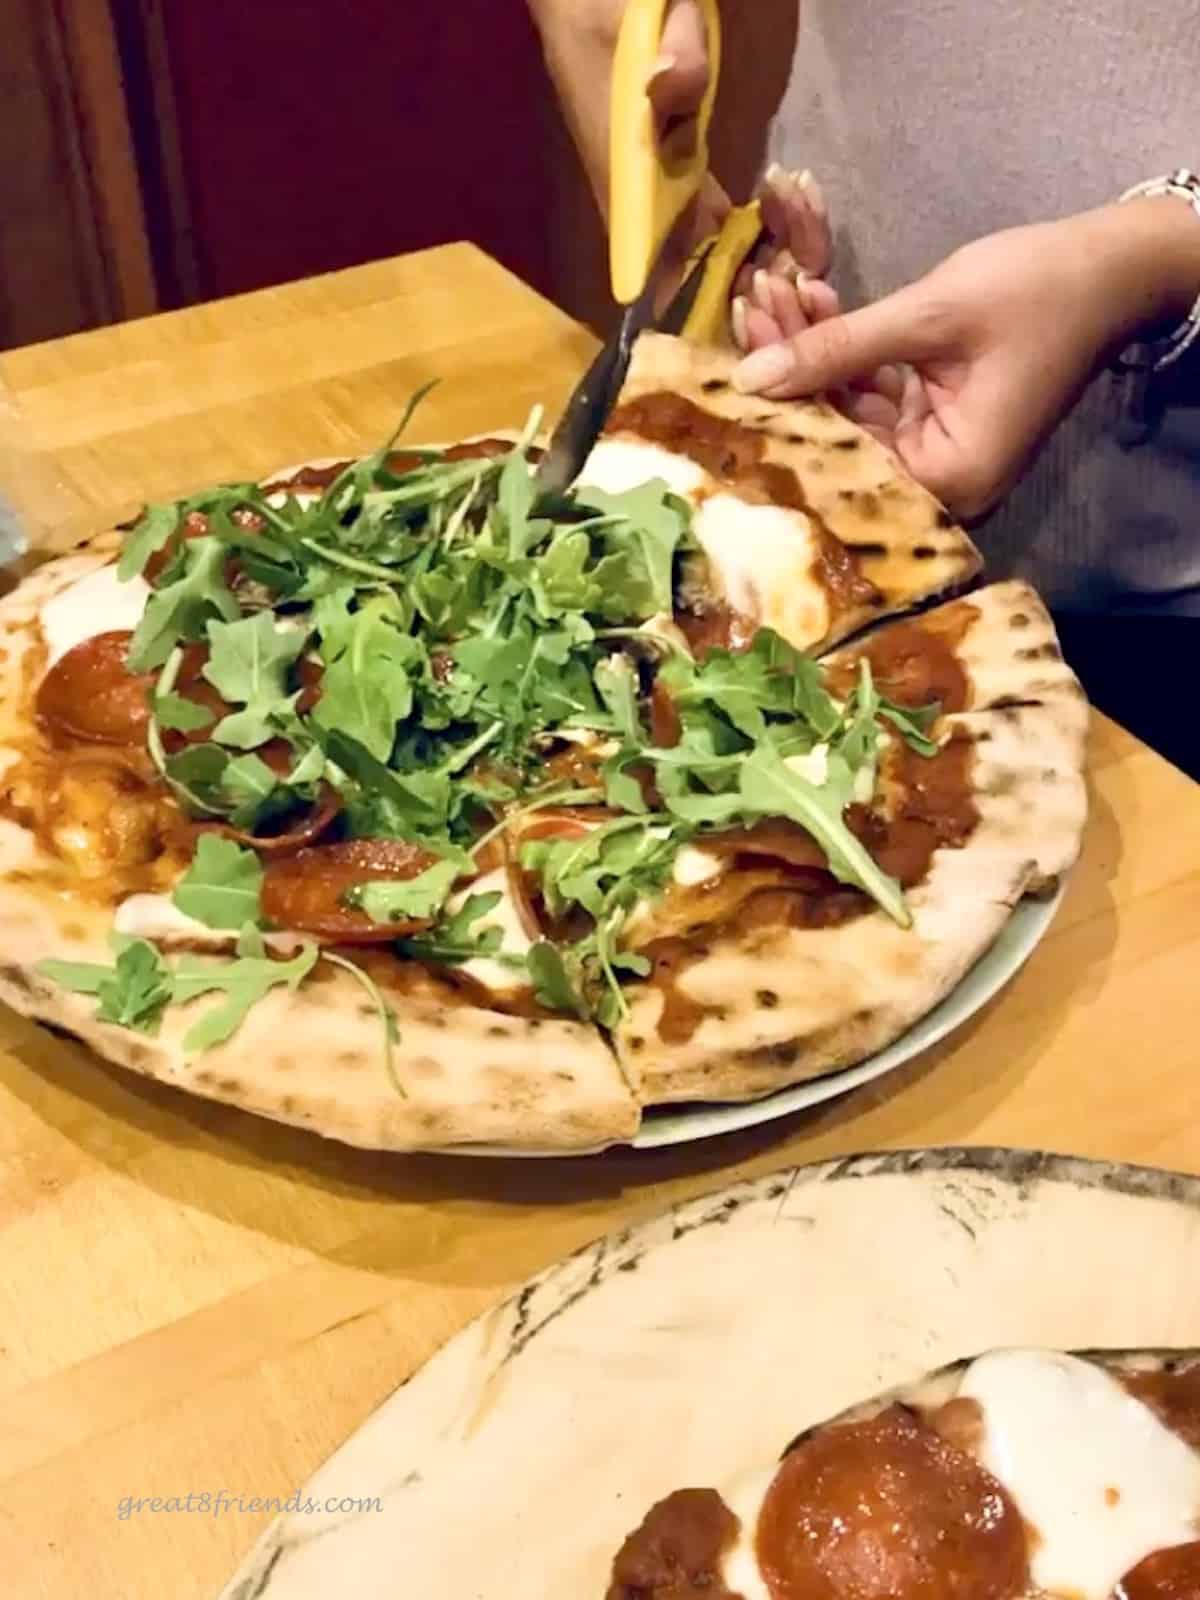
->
[[262, 838, 438, 944]]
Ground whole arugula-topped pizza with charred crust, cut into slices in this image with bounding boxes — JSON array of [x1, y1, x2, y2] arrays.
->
[[0, 336, 1086, 1150]]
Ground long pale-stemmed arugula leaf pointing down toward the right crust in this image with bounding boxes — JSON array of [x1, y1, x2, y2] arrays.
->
[[738, 746, 912, 928]]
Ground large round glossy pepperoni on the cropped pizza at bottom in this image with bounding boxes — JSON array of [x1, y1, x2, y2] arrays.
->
[[755, 1405, 1029, 1600]]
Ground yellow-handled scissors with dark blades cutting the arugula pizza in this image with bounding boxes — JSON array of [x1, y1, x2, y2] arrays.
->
[[536, 0, 762, 496]]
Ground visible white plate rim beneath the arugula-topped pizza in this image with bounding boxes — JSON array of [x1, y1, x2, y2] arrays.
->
[[442, 883, 1066, 1158]]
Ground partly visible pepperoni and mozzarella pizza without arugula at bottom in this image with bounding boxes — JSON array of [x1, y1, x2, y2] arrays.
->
[[608, 1350, 1200, 1600]]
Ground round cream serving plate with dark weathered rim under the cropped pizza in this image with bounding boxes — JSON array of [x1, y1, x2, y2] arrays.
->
[[224, 1150, 1200, 1600]]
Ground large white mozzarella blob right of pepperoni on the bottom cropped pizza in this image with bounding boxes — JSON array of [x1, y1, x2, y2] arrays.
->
[[958, 1350, 1200, 1600]]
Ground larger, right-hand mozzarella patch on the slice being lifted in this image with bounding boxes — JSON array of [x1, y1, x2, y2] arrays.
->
[[693, 494, 830, 650]]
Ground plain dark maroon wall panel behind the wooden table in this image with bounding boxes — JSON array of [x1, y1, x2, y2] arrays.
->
[[150, 0, 549, 299]]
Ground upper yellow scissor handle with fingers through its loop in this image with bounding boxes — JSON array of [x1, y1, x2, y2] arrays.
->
[[608, 0, 722, 306]]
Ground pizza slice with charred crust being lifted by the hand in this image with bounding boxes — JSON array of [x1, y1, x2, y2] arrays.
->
[[581, 333, 982, 653]]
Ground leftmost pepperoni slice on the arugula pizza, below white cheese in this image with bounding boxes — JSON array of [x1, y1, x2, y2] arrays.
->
[[37, 630, 155, 746]]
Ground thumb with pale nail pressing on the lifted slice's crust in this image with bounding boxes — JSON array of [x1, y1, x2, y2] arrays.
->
[[733, 285, 946, 398]]
